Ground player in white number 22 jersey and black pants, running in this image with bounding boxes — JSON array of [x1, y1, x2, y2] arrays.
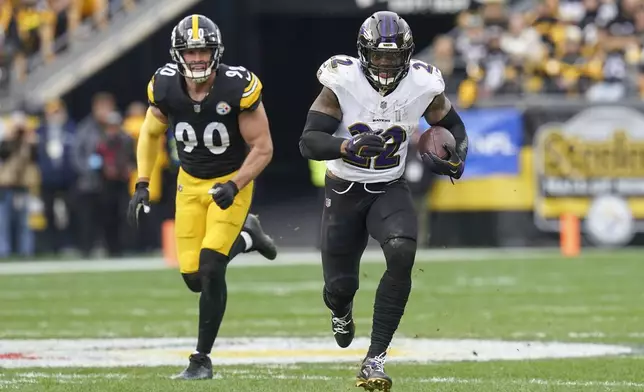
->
[[300, 11, 467, 391]]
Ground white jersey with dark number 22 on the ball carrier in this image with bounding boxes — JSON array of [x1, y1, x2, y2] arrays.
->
[[317, 56, 445, 183]]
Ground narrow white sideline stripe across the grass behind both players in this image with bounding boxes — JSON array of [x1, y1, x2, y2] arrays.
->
[[0, 248, 637, 275]]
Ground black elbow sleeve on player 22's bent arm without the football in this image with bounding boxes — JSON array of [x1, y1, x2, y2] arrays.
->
[[300, 110, 344, 161]]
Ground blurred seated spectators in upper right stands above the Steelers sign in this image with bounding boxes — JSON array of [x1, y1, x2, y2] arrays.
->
[[424, 0, 644, 107]]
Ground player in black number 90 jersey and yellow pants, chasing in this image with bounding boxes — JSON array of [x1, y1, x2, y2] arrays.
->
[[128, 15, 277, 379]]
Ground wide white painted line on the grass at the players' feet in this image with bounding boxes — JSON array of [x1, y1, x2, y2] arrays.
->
[[0, 337, 633, 368]]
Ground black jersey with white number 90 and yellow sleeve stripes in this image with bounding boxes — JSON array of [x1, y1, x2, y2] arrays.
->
[[148, 63, 262, 179]]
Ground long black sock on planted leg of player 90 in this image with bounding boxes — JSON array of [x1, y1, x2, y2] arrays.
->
[[197, 249, 228, 354]]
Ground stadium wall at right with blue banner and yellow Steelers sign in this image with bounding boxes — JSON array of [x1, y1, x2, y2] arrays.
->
[[421, 98, 644, 246]]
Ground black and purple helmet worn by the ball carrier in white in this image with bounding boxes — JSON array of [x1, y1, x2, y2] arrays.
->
[[358, 11, 414, 92]]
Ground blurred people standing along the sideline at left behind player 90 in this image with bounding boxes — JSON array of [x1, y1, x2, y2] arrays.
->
[[0, 93, 177, 259]]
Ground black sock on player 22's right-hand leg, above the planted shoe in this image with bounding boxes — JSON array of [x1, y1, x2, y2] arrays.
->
[[367, 271, 411, 358]]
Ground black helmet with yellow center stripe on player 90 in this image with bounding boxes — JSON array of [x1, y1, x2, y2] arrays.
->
[[170, 14, 224, 83]]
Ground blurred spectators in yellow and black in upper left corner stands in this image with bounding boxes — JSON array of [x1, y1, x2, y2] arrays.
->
[[0, 0, 136, 94]]
